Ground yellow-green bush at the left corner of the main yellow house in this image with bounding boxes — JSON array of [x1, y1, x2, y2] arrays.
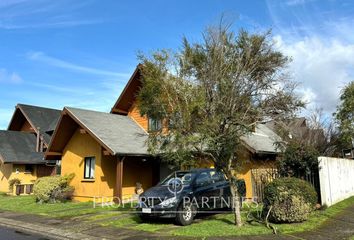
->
[[33, 174, 74, 203]]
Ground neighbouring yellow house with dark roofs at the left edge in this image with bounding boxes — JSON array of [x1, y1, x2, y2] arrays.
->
[[0, 104, 60, 194]]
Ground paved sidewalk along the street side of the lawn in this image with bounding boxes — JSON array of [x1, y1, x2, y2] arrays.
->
[[0, 206, 354, 240]]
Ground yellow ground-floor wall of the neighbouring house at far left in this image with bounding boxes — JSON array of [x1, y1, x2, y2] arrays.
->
[[0, 164, 37, 192]]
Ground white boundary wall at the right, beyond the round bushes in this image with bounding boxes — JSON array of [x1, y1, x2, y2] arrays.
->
[[318, 157, 354, 206]]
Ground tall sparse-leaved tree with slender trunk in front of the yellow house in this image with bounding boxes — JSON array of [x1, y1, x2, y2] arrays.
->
[[138, 23, 303, 226]]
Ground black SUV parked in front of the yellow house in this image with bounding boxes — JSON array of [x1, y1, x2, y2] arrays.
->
[[137, 169, 242, 225]]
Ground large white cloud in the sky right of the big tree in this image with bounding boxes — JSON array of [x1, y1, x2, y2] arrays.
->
[[275, 35, 354, 113]]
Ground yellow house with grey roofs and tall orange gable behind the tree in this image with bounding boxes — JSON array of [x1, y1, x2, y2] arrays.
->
[[46, 66, 280, 201]]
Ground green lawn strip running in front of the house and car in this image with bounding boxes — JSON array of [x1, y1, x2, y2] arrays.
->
[[0, 194, 354, 237]]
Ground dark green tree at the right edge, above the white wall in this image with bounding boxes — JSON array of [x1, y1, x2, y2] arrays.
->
[[335, 81, 354, 148]]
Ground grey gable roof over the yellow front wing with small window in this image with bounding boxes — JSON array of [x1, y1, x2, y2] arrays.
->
[[46, 107, 148, 159]]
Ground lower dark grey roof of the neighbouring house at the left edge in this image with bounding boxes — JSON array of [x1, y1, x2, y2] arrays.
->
[[0, 130, 45, 164]]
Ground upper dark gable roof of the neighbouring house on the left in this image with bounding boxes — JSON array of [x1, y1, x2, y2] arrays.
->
[[8, 104, 61, 144]]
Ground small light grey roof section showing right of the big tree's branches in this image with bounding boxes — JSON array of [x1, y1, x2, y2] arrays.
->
[[241, 124, 282, 154]]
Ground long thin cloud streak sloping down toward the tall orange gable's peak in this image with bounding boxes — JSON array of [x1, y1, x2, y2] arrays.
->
[[27, 52, 130, 77]]
